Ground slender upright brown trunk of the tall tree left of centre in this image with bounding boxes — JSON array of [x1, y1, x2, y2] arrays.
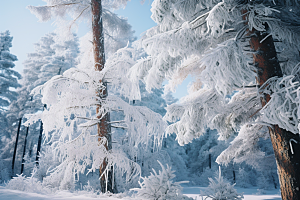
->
[[91, 0, 117, 193]]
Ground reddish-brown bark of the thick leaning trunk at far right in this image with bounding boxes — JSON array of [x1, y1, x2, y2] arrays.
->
[[243, 9, 300, 200]]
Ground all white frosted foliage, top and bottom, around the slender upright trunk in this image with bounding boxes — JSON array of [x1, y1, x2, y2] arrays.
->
[[22, 1, 165, 189]]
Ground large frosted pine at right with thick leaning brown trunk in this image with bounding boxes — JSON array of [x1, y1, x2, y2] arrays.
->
[[131, 0, 300, 199]]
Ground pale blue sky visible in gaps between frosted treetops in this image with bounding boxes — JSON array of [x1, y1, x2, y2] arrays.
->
[[0, 0, 187, 98]]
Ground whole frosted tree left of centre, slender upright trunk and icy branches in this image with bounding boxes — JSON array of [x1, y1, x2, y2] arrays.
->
[[24, 1, 169, 192]]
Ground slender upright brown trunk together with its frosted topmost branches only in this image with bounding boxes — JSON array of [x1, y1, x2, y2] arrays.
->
[[28, 0, 132, 192]]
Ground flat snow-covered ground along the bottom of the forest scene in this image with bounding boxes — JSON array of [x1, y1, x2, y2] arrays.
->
[[0, 186, 281, 200]]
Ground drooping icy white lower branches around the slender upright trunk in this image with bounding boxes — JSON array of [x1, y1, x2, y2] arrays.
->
[[24, 53, 166, 189]]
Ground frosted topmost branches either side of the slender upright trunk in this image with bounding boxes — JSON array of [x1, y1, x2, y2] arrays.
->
[[27, 0, 134, 42]]
